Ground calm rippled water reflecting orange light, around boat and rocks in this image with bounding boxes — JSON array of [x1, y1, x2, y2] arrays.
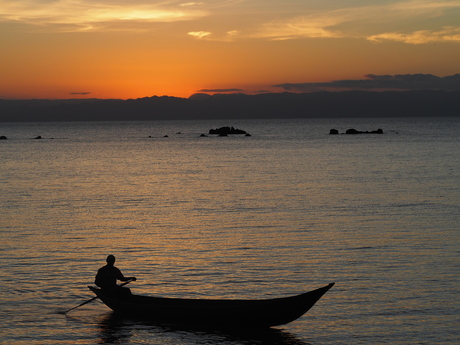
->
[[0, 118, 460, 345]]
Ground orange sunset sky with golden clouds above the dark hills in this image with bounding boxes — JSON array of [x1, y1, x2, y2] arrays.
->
[[0, 0, 460, 99]]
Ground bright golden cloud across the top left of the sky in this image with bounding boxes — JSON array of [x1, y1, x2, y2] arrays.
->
[[0, 0, 206, 31]]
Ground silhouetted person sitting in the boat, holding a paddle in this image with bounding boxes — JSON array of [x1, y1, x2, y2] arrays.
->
[[94, 255, 136, 296]]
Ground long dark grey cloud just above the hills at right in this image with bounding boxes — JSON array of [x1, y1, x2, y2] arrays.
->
[[274, 74, 460, 92]]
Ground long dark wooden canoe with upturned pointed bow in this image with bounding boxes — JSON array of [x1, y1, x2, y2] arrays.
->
[[88, 283, 334, 327]]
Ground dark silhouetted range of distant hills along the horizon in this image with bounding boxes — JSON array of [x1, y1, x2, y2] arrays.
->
[[0, 91, 460, 122]]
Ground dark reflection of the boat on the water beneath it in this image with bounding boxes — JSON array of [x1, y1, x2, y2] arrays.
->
[[98, 312, 308, 345]]
